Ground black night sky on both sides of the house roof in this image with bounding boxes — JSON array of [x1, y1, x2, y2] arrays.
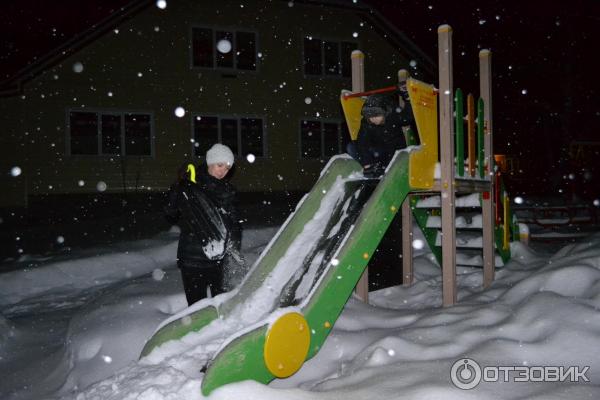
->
[[0, 0, 600, 197]]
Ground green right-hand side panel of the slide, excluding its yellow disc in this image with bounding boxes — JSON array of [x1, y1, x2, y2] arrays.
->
[[202, 153, 410, 395]]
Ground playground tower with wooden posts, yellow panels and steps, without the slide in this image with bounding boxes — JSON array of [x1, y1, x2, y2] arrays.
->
[[341, 25, 510, 306]]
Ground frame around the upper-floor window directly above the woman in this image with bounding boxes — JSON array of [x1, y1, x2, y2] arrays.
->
[[188, 24, 260, 74]]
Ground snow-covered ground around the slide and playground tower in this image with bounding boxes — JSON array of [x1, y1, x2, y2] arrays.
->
[[0, 222, 600, 400]]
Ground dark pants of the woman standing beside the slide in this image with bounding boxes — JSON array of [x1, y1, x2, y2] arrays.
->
[[177, 260, 224, 305]]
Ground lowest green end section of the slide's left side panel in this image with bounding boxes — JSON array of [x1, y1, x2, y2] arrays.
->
[[140, 306, 218, 358]]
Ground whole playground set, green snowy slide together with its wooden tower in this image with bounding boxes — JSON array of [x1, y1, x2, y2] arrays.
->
[[141, 25, 512, 395]]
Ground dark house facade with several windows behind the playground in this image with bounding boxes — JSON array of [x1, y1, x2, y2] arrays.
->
[[0, 0, 434, 207]]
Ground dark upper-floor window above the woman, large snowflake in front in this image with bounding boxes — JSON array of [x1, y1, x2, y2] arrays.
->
[[192, 28, 256, 71]]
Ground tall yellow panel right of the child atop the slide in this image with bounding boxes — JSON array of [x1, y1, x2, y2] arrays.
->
[[406, 78, 438, 189]]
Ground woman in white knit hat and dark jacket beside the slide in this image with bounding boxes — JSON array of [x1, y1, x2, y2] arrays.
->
[[165, 144, 242, 305]]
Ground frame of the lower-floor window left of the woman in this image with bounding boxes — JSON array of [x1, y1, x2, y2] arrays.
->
[[65, 107, 156, 158]]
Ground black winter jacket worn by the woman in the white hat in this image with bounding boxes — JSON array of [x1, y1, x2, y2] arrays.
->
[[164, 168, 241, 266]]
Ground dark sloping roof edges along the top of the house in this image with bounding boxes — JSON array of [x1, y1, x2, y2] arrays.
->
[[0, 0, 435, 96]]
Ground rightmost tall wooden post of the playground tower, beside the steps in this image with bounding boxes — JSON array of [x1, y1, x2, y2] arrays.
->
[[479, 50, 496, 287]]
